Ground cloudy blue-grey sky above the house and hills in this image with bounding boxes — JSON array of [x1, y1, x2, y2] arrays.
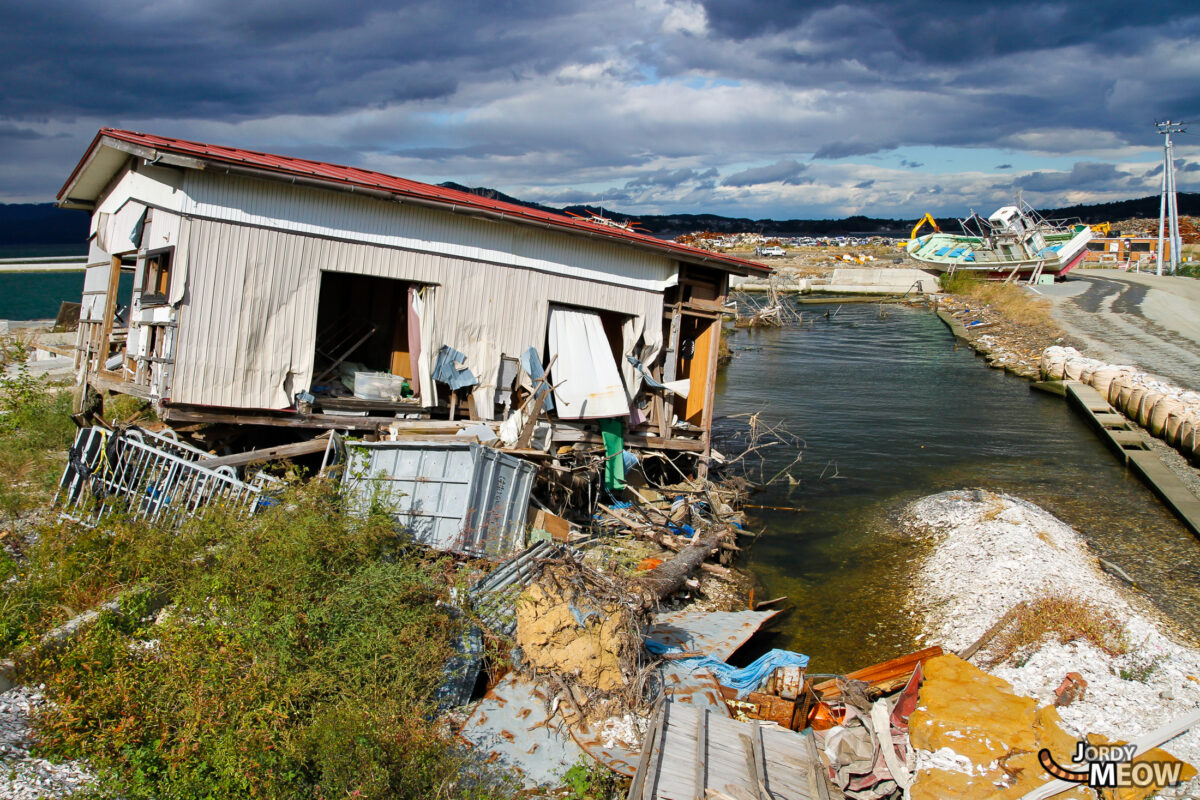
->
[[0, 0, 1200, 218]]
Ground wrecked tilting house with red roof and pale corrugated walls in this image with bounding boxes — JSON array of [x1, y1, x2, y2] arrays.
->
[[58, 128, 769, 470]]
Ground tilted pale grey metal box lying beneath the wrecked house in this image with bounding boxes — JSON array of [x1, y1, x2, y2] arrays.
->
[[342, 441, 536, 559]]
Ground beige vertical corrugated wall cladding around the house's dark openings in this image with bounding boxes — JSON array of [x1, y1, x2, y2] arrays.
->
[[170, 215, 662, 410]]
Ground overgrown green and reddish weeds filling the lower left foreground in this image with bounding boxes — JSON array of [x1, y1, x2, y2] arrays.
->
[[0, 379, 512, 799]]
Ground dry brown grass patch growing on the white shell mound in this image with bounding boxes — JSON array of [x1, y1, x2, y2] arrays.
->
[[988, 595, 1129, 667]]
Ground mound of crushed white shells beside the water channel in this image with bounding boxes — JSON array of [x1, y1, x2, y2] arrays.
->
[[905, 489, 1200, 798]]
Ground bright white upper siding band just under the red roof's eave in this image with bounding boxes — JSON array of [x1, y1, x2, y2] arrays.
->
[[181, 170, 677, 291]]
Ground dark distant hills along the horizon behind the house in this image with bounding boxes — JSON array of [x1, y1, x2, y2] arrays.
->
[[0, 189, 1200, 258]]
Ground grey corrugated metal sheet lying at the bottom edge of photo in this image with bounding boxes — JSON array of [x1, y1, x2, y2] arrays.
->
[[629, 703, 829, 800]]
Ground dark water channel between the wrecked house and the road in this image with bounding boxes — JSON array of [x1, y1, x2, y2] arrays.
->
[[716, 299, 1200, 672]]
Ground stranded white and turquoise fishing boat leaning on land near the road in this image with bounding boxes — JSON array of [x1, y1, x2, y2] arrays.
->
[[906, 200, 1092, 283]]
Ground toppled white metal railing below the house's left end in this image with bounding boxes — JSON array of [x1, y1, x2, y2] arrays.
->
[[55, 427, 263, 525]]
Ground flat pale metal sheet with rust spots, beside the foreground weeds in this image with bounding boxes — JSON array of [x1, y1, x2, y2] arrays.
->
[[458, 673, 583, 788]]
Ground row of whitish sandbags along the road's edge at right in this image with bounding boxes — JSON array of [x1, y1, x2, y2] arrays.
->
[[1042, 345, 1200, 461]]
